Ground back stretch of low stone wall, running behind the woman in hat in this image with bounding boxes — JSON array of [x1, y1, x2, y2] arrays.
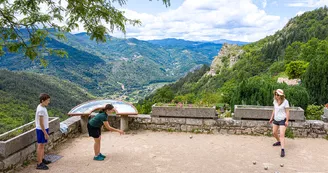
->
[[109, 115, 328, 138]]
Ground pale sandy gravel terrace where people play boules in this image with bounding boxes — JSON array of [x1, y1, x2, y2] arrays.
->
[[20, 131, 328, 173]]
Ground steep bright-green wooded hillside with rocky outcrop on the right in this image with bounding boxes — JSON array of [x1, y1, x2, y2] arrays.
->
[[137, 7, 328, 118]]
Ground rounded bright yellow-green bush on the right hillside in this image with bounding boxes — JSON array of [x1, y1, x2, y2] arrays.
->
[[286, 61, 309, 79]]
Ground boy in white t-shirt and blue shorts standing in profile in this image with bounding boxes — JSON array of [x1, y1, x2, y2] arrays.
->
[[35, 93, 51, 170]]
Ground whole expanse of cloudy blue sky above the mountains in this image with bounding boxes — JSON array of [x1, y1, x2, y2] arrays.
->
[[100, 0, 328, 42]]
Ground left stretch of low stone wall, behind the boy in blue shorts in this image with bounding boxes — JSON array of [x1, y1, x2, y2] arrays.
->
[[0, 117, 80, 172]]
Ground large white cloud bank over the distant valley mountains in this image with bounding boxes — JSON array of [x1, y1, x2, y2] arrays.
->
[[107, 0, 287, 41]]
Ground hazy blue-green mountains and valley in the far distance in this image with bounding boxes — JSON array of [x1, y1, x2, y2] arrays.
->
[[0, 33, 222, 101]]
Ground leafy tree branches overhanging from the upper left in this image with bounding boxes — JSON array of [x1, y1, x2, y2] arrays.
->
[[0, 0, 170, 63]]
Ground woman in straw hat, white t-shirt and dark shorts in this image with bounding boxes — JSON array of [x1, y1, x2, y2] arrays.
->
[[269, 89, 289, 157]]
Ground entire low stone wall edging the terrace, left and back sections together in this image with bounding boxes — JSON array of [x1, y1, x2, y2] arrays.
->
[[0, 115, 328, 172]]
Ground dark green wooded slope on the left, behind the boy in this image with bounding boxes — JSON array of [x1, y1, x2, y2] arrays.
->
[[0, 70, 95, 134]]
